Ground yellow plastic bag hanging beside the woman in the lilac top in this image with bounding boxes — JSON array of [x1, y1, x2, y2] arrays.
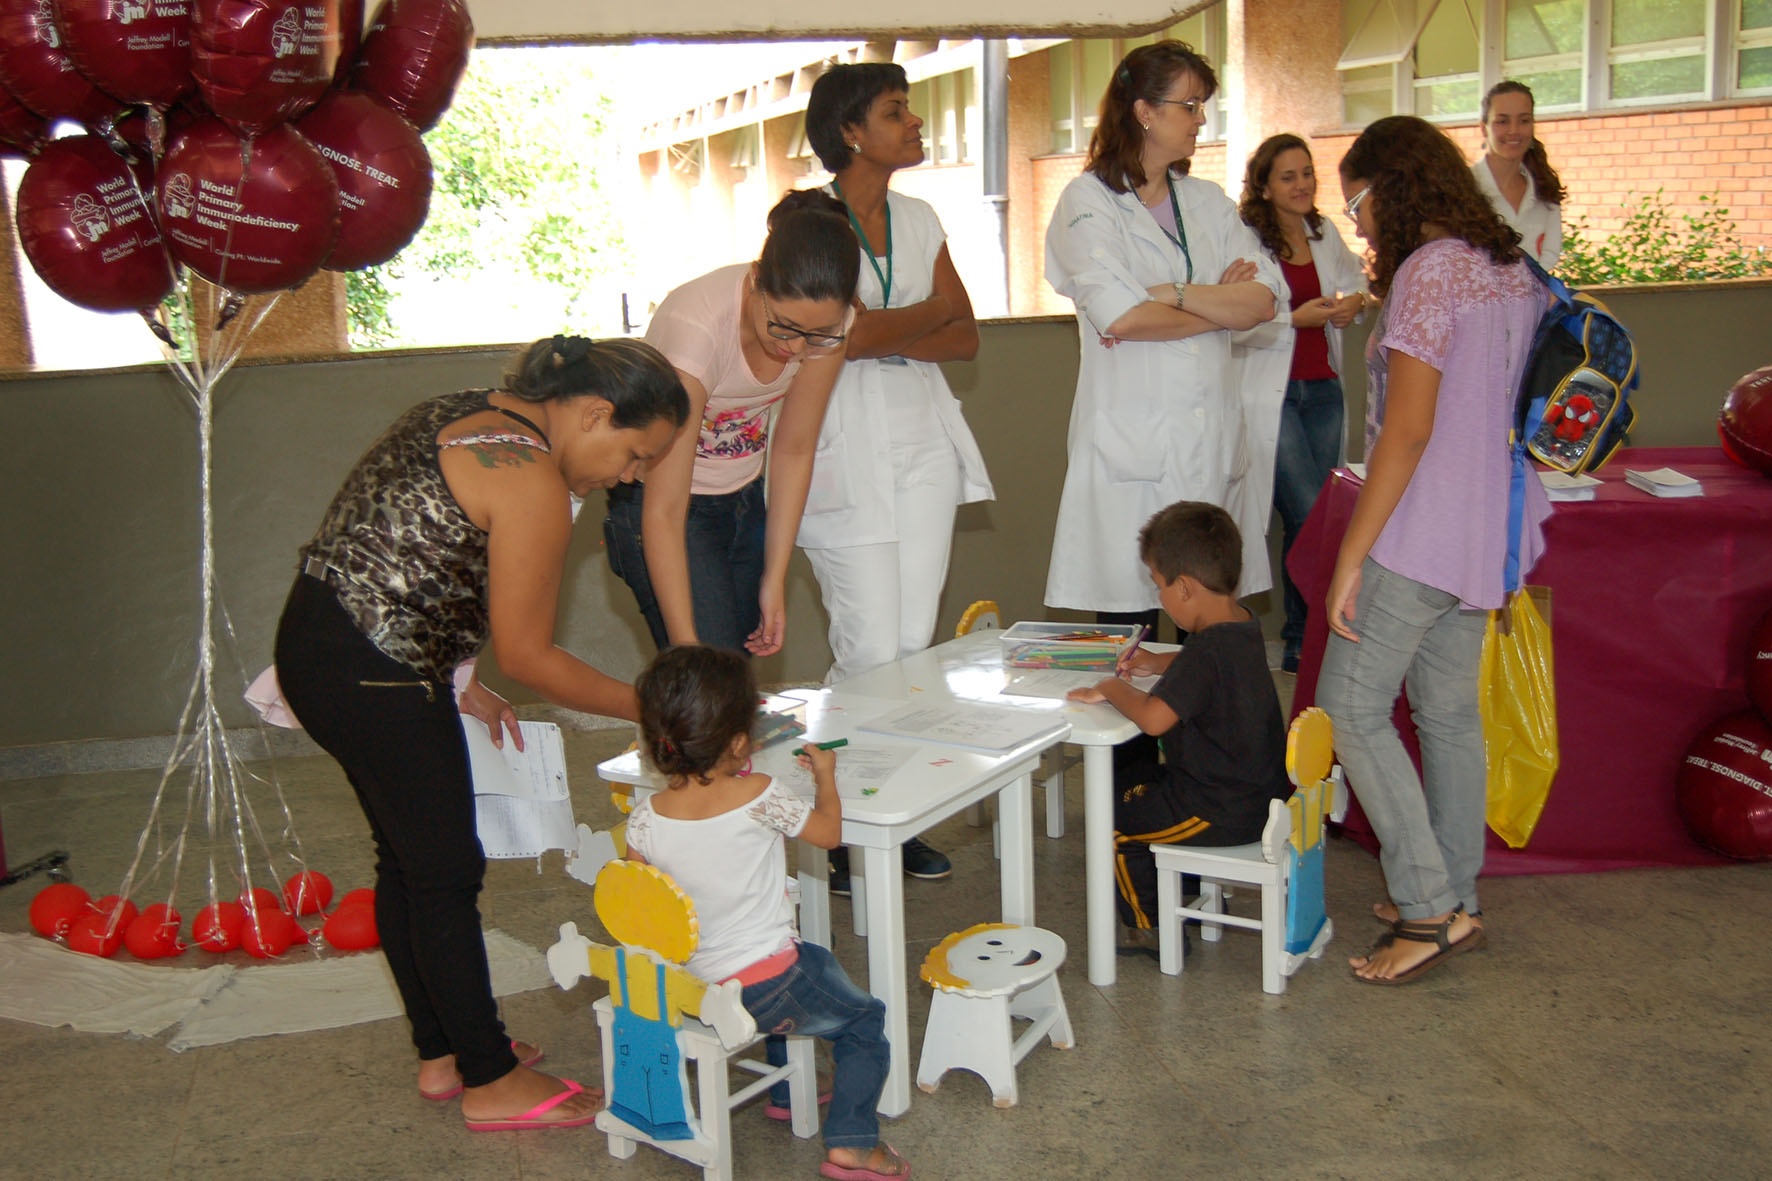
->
[[1478, 587, 1558, 849]]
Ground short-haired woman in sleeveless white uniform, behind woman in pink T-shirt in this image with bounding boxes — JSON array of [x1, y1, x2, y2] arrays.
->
[[799, 62, 992, 888]]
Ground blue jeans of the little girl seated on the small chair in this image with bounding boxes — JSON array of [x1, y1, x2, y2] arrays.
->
[[744, 943, 891, 1149]]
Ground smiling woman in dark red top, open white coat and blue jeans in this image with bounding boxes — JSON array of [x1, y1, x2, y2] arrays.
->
[[1232, 135, 1366, 672]]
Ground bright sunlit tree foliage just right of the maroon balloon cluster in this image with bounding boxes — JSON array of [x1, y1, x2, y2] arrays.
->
[[346, 46, 629, 348]]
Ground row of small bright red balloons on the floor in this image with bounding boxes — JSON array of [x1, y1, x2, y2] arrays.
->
[[30, 869, 381, 959]]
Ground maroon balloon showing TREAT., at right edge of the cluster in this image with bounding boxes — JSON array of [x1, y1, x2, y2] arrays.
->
[[296, 90, 431, 271]]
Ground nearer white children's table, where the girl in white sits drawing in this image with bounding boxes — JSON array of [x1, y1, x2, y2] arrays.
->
[[597, 670, 1063, 1115]]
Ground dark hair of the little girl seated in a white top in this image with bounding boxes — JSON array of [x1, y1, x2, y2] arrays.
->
[[634, 644, 757, 784]]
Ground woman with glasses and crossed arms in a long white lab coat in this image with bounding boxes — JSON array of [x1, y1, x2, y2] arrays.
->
[[1045, 41, 1285, 619]]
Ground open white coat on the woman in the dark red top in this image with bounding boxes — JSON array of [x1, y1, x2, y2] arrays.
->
[[1230, 218, 1366, 532]]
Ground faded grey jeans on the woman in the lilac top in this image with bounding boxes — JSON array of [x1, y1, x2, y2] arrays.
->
[[1317, 559, 1488, 919]]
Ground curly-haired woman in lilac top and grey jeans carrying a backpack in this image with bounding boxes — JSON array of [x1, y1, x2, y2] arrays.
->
[[1317, 115, 1551, 984]]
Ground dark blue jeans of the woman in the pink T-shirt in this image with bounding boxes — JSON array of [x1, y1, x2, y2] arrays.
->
[[602, 477, 767, 653]]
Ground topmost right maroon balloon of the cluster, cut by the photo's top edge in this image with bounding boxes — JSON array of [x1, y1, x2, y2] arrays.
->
[[351, 0, 473, 131]]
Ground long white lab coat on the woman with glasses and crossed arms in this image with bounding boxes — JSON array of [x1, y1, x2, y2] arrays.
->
[[1045, 172, 1286, 612]]
